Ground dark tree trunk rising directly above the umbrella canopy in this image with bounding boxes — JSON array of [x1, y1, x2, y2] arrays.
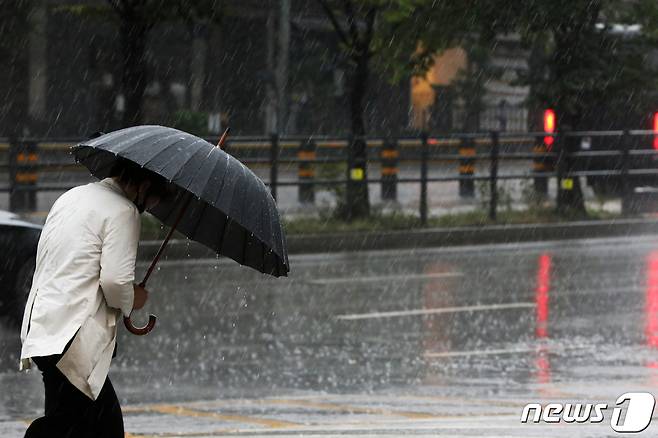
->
[[121, 16, 149, 127]]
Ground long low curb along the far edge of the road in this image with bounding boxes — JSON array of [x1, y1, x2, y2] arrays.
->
[[138, 219, 658, 260]]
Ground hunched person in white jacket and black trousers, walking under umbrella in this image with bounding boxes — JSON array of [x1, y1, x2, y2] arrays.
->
[[20, 160, 171, 438]]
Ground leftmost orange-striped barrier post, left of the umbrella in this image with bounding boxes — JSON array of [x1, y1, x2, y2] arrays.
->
[[9, 140, 39, 212]]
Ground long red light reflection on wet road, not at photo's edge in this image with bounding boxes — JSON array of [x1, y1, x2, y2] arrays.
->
[[535, 253, 551, 383]]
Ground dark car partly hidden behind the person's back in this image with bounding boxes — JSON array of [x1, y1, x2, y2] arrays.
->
[[0, 210, 41, 321]]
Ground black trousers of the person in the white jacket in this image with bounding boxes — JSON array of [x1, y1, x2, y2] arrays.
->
[[25, 350, 124, 438]]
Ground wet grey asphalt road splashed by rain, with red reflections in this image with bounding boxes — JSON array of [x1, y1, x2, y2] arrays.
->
[[0, 236, 658, 437]]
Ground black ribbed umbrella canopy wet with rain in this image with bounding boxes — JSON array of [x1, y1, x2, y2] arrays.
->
[[72, 125, 289, 277]]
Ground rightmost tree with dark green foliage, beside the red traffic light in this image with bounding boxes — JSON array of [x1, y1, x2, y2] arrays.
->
[[519, 0, 658, 215]]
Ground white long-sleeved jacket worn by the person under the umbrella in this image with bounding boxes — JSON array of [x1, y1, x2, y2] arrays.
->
[[20, 178, 140, 400]]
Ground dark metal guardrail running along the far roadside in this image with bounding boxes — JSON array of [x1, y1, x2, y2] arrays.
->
[[0, 130, 658, 223]]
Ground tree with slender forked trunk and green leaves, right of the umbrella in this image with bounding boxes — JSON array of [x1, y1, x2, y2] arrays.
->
[[316, 0, 514, 220]]
